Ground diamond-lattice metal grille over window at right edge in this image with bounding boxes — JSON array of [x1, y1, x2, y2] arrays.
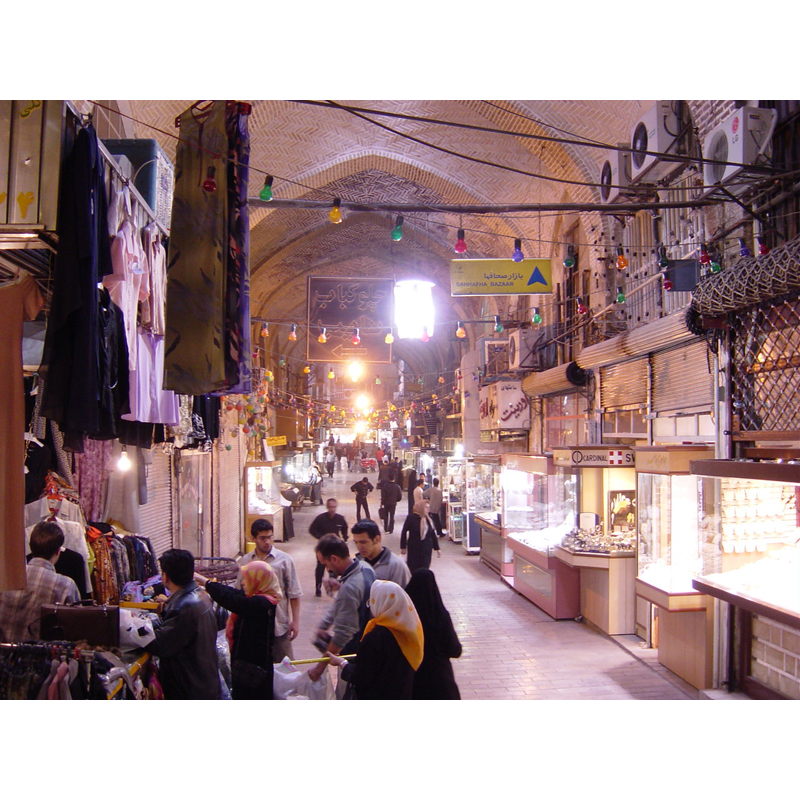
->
[[731, 295, 800, 432]]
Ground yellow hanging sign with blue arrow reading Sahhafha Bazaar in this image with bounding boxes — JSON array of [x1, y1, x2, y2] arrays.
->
[[450, 258, 553, 297]]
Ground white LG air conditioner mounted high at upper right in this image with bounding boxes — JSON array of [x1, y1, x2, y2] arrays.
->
[[703, 106, 777, 194]]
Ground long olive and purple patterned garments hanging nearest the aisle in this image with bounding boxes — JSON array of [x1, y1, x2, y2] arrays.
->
[[164, 101, 251, 395]]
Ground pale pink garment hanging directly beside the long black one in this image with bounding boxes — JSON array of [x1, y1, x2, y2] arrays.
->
[[103, 220, 150, 372]]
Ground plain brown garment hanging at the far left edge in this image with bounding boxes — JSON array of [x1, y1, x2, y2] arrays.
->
[[0, 272, 43, 591]]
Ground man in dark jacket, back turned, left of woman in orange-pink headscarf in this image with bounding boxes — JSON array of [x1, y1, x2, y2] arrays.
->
[[145, 549, 220, 700]]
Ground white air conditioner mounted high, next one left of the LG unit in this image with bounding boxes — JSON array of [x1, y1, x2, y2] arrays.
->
[[631, 100, 683, 183]]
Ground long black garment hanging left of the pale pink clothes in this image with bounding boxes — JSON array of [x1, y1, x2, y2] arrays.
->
[[41, 125, 113, 441]]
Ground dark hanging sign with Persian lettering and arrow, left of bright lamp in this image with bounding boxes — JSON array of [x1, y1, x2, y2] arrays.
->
[[306, 277, 394, 364]]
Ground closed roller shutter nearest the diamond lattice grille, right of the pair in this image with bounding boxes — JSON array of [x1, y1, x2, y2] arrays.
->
[[650, 341, 714, 413]]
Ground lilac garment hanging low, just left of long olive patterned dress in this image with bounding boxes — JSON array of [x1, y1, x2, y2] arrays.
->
[[122, 328, 180, 425]]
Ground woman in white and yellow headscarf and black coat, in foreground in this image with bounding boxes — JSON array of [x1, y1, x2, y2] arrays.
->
[[327, 580, 425, 700]]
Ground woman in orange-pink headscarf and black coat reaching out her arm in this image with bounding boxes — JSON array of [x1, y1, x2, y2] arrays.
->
[[195, 561, 282, 700]]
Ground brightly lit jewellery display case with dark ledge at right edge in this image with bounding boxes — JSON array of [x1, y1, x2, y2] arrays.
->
[[691, 451, 800, 699]]
